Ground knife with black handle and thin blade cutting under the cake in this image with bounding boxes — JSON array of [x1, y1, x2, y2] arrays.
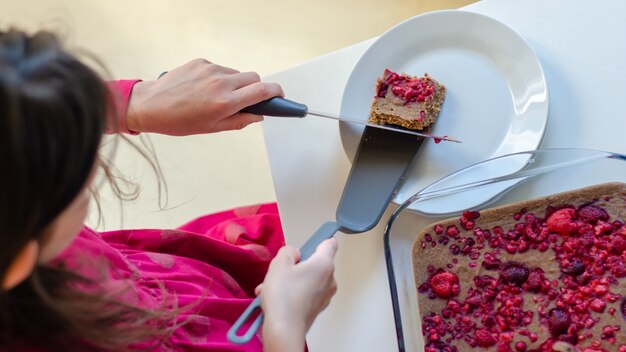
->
[[241, 97, 461, 143]]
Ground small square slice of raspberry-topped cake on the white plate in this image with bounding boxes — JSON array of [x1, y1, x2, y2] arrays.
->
[[369, 69, 446, 130]]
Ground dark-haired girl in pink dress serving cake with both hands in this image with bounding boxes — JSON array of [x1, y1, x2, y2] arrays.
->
[[0, 30, 336, 351]]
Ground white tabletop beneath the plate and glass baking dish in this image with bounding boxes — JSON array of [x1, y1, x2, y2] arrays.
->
[[263, 0, 626, 351]]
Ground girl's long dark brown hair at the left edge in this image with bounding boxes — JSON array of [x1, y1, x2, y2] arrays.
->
[[0, 30, 176, 350]]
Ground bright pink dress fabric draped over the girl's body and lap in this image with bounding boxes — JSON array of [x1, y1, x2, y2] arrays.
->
[[56, 204, 284, 351]]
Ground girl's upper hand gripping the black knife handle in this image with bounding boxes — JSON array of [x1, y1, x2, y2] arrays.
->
[[126, 59, 283, 136]]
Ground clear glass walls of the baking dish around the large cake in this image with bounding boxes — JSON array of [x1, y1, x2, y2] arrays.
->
[[385, 150, 626, 352]]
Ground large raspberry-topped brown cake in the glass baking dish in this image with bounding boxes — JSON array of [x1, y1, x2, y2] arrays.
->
[[413, 183, 626, 352]]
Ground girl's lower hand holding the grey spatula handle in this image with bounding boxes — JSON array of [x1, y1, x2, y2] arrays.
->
[[256, 238, 337, 351]]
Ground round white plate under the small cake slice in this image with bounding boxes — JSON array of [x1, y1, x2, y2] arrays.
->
[[339, 10, 548, 214]]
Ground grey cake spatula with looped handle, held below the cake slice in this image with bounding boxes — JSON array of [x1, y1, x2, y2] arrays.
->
[[228, 121, 424, 344]]
